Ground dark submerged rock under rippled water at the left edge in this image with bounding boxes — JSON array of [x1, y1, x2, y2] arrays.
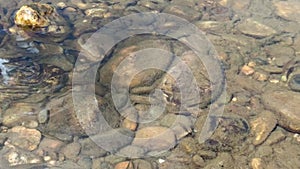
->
[[0, 57, 68, 103]]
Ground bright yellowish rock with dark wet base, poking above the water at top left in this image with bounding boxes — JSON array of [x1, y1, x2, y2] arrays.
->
[[10, 3, 71, 42]]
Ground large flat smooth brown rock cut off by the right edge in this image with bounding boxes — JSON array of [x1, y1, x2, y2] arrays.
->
[[262, 91, 300, 133]]
